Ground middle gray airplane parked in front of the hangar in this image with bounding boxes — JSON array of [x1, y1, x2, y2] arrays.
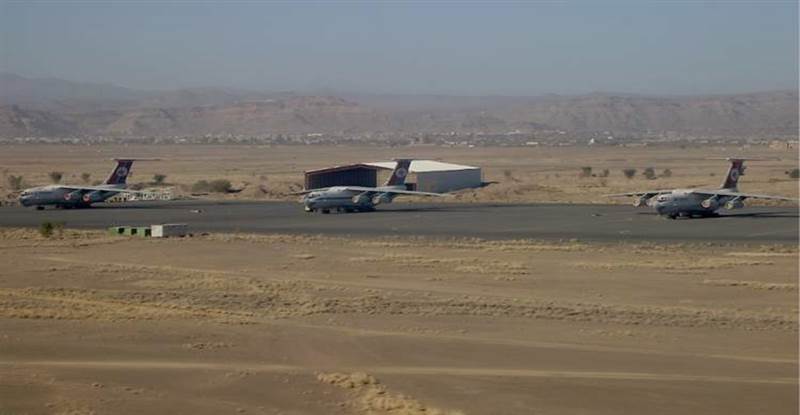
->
[[302, 159, 443, 213]]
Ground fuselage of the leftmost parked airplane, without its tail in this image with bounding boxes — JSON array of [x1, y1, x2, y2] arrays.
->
[[19, 185, 124, 208]]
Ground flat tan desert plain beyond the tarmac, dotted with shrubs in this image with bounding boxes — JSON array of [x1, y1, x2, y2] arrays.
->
[[0, 144, 798, 204]]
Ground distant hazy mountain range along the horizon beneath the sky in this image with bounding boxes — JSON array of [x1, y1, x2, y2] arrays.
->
[[0, 73, 798, 137]]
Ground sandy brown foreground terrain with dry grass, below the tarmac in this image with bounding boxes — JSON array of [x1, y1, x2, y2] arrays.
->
[[0, 229, 798, 414]]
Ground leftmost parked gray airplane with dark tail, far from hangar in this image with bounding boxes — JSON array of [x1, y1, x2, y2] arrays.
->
[[19, 159, 153, 209]]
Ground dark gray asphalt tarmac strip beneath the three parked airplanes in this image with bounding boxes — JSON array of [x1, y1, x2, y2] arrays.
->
[[0, 201, 798, 243]]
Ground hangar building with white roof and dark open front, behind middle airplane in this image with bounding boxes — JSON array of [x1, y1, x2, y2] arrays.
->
[[305, 160, 482, 193]]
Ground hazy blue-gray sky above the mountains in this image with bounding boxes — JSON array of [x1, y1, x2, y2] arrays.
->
[[0, 0, 798, 95]]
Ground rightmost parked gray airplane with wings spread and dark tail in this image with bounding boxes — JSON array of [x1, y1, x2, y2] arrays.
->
[[608, 158, 796, 219]]
